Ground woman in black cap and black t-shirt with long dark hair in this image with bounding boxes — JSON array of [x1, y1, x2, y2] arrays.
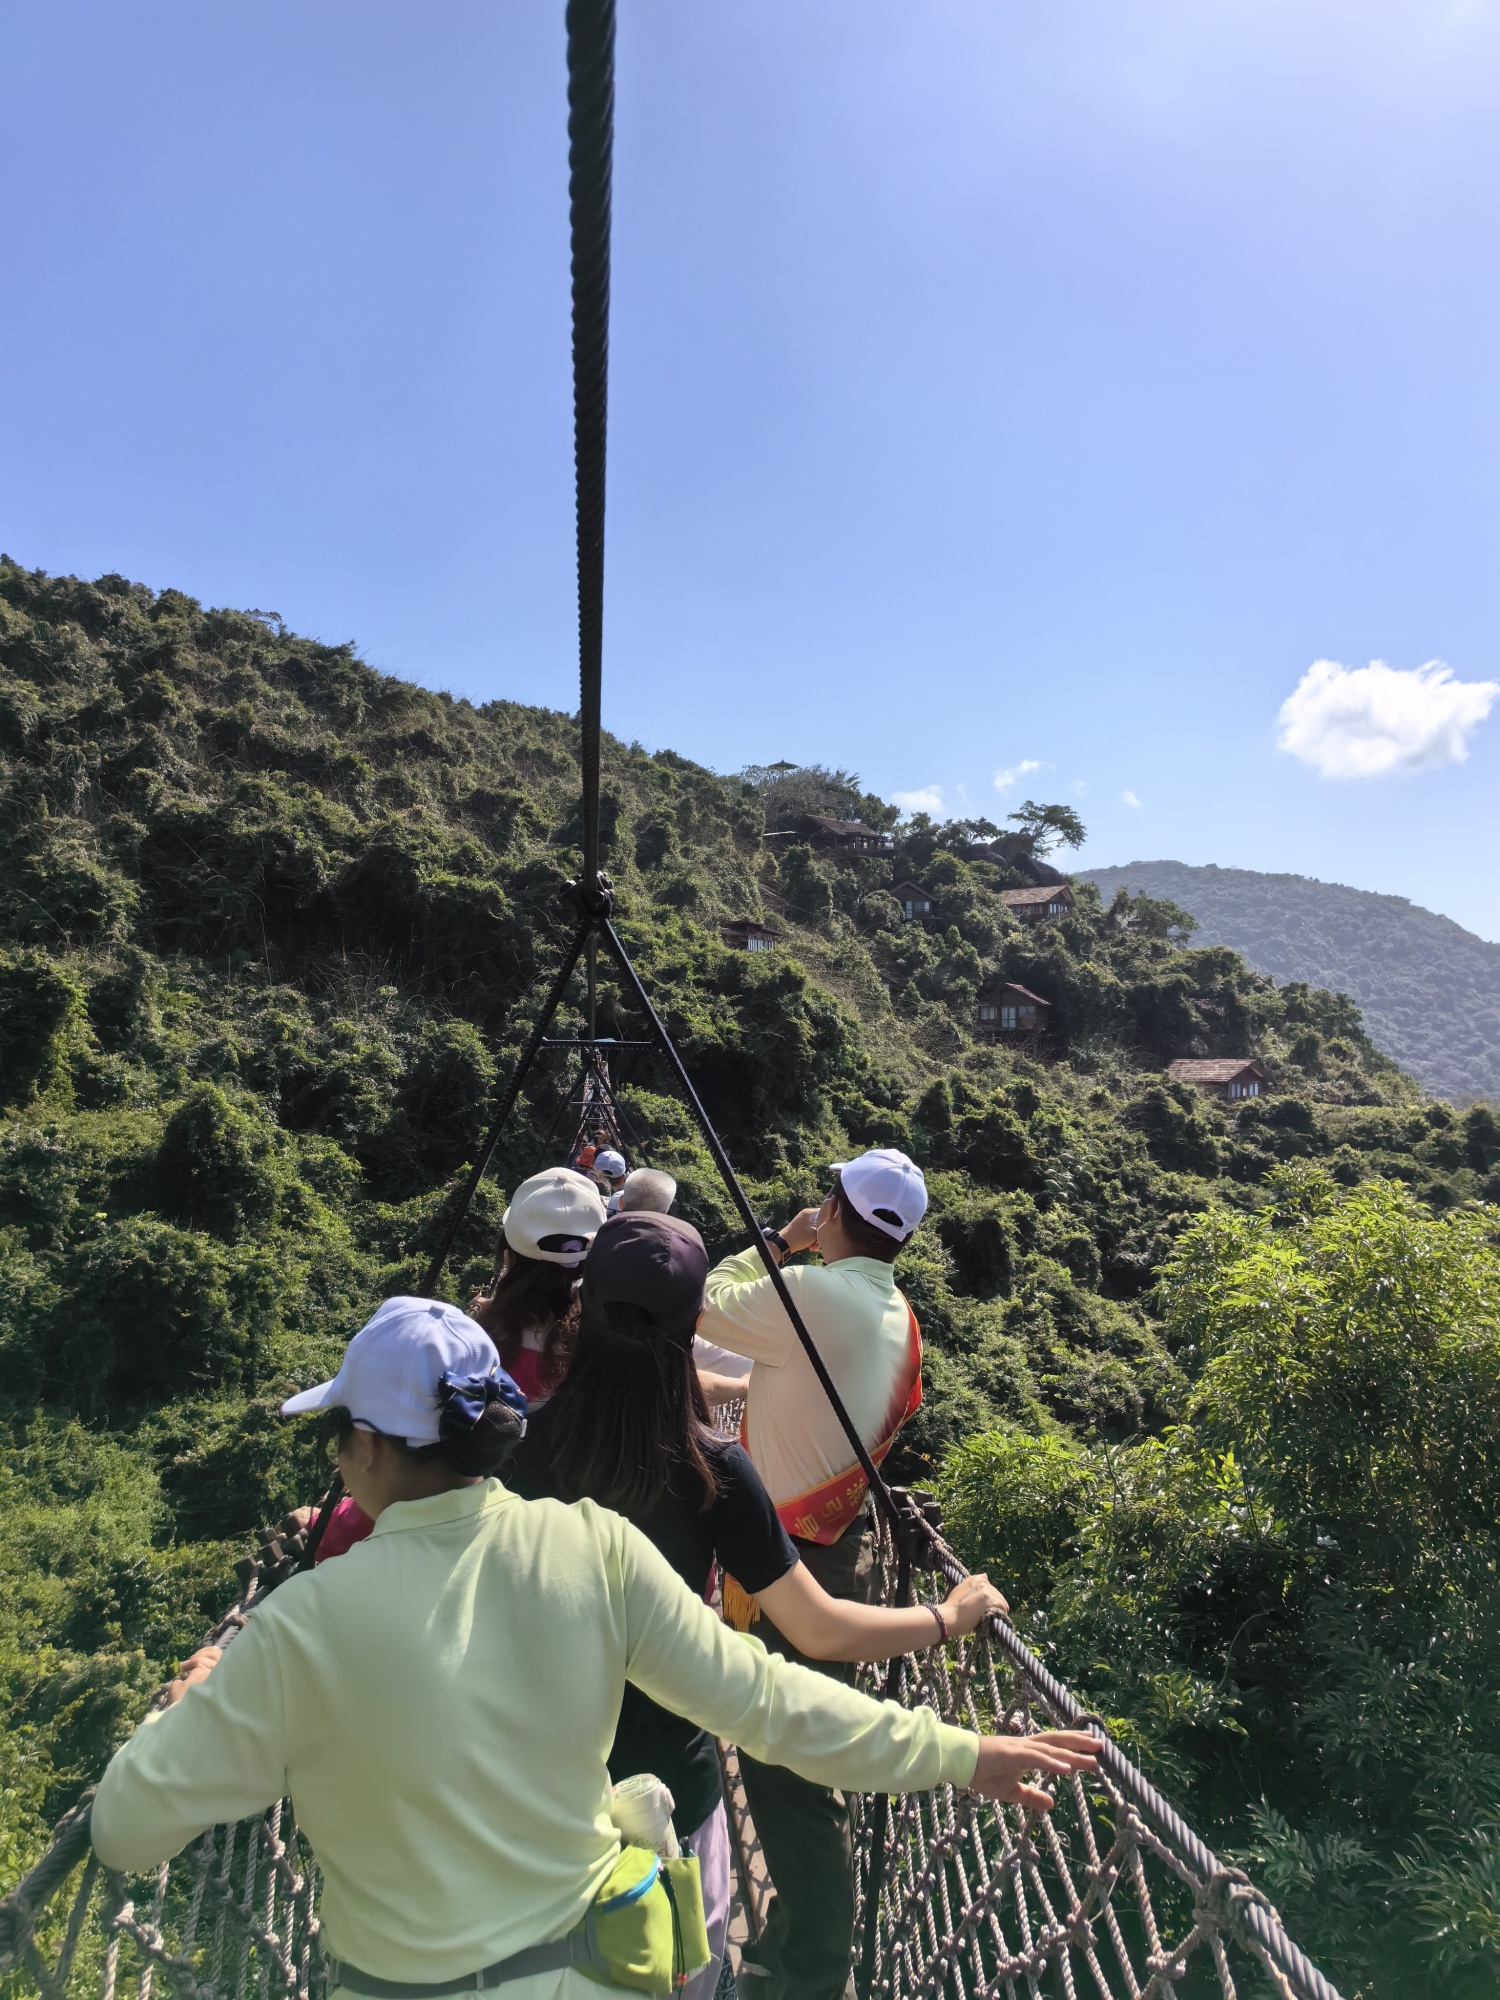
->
[[506, 1212, 1006, 2000]]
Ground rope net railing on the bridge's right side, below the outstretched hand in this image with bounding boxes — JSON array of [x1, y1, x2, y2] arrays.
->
[[856, 1508, 1338, 2000]]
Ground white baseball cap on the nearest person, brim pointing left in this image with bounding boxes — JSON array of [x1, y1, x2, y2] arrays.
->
[[282, 1298, 500, 1444]]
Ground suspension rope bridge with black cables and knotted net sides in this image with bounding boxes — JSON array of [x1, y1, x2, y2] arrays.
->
[[0, 11, 1340, 2000]]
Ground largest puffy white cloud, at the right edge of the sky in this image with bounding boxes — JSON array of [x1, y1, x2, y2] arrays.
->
[[1276, 660, 1500, 778]]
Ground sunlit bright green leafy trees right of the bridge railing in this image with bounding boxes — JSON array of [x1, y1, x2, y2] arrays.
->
[[944, 1162, 1500, 1996]]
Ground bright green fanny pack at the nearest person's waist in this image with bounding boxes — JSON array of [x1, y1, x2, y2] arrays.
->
[[572, 1848, 712, 1994]]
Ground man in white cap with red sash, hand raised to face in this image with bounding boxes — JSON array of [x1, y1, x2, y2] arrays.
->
[[700, 1148, 928, 2000]]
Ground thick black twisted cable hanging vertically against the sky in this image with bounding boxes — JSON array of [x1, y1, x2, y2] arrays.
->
[[568, 0, 614, 900]]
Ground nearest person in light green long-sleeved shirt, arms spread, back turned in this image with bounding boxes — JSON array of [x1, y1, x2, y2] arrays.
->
[[92, 1300, 1094, 2000]]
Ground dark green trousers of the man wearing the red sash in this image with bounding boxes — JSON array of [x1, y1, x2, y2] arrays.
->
[[740, 1520, 878, 2000]]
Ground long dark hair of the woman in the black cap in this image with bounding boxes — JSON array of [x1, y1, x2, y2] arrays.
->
[[550, 1280, 718, 1514]]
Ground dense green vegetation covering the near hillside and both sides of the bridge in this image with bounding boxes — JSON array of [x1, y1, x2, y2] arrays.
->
[[0, 562, 1500, 1992]]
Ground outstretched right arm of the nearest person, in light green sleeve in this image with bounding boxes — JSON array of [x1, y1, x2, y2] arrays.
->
[[612, 1502, 1096, 1810]]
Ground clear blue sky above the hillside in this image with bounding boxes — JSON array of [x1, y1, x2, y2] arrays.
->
[[0, 0, 1500, 938]]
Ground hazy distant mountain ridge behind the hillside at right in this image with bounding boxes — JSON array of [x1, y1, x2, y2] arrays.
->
[[1078, 862, 1500, 1100]]
